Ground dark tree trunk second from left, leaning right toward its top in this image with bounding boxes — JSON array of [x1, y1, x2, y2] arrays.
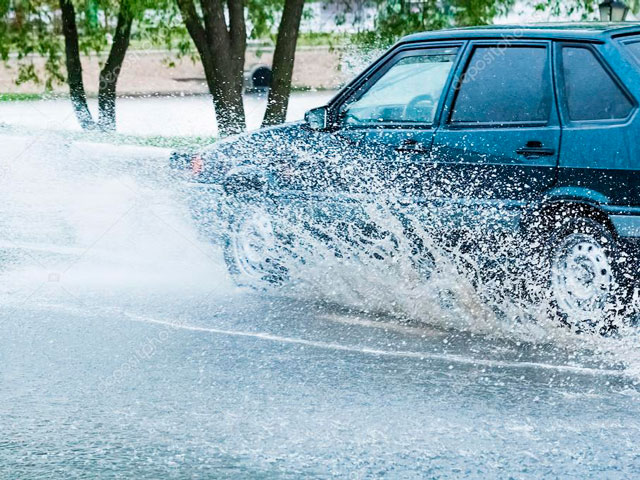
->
[[98, 0, 133, 132]]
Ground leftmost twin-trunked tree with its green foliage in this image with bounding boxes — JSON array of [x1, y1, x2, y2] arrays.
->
[[0, 0, 176, 130]]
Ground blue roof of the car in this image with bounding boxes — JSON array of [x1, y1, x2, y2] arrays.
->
[[400, 22, 640, 43]]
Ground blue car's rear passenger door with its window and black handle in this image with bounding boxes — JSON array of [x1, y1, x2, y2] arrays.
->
[[432, 41, 561, 232]]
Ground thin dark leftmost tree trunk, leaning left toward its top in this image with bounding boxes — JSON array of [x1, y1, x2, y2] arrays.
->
[[60, 0, 95, 130]]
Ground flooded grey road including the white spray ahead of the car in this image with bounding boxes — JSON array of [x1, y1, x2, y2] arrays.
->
[[0, 135, 640, 479]]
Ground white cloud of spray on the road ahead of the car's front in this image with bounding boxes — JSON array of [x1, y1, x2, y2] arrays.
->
[[0, 134, 232, 301]]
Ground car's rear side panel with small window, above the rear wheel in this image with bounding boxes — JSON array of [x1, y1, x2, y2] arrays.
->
[[556, 43, 638, 210]]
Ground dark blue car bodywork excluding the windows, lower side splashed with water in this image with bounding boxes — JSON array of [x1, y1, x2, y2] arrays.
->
[[182, 22, 640, 244]]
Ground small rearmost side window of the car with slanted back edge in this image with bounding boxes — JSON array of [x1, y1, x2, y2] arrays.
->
[[562, 47, 633, 121]]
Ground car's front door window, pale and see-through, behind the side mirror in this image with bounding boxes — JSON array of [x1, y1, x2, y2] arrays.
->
[[342, 48, 458, 126]]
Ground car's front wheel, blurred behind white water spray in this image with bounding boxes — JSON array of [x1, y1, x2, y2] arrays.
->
[[223, 207, 288, 290]]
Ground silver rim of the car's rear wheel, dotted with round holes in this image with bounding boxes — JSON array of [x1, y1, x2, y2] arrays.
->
[[551, 233, 615, 324]]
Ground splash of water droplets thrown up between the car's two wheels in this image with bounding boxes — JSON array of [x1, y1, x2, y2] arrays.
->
[[218, 193, 640, 376]]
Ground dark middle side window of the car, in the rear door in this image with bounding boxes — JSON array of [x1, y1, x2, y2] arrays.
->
[[450, 46, 553, 125]]
